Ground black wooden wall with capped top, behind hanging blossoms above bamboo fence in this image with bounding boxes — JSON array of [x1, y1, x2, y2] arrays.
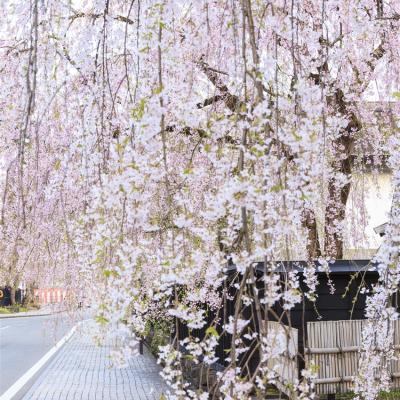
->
[[177, 260, 378, 372]]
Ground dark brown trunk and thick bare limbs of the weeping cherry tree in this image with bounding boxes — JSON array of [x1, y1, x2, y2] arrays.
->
[[197, 42, 385, 259]]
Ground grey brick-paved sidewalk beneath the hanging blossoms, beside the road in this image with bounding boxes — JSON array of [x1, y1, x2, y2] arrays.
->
[[23, 324, 166, 400]]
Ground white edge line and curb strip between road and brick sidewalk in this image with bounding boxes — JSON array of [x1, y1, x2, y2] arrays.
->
[[0, 323, 79, 400]]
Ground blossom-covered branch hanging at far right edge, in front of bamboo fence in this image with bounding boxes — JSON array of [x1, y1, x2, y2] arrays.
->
[[355, 132, 400, 400]]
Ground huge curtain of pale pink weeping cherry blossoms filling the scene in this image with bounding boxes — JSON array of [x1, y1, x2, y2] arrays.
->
[[0, 0, 400, 400]]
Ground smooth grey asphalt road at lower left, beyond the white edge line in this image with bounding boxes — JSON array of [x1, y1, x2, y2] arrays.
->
[[0, 314, 75, 396]]
